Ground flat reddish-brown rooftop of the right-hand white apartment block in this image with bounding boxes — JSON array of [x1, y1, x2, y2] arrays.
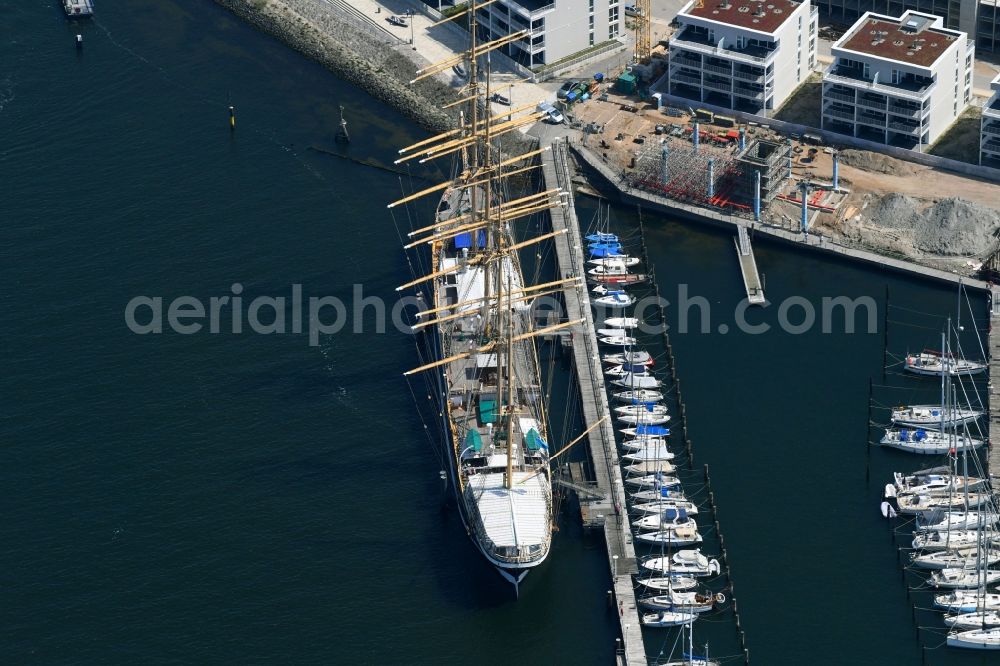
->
[[834, 13, 960, 67]]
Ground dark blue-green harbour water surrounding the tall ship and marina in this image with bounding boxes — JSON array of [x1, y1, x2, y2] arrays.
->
[[0, 0, 986, 664]]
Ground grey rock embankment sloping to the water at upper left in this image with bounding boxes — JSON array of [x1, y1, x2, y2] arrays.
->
[[215, 0, 457, 132]]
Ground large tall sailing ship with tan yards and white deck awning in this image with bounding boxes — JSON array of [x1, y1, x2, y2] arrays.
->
[[389, 1, 578, 593]]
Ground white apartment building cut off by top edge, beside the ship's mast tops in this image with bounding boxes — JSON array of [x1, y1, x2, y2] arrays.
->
[[476, 0, 616, 67]]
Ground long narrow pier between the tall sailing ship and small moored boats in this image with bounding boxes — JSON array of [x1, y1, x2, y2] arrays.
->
[[542, 140, 647, 665]]
